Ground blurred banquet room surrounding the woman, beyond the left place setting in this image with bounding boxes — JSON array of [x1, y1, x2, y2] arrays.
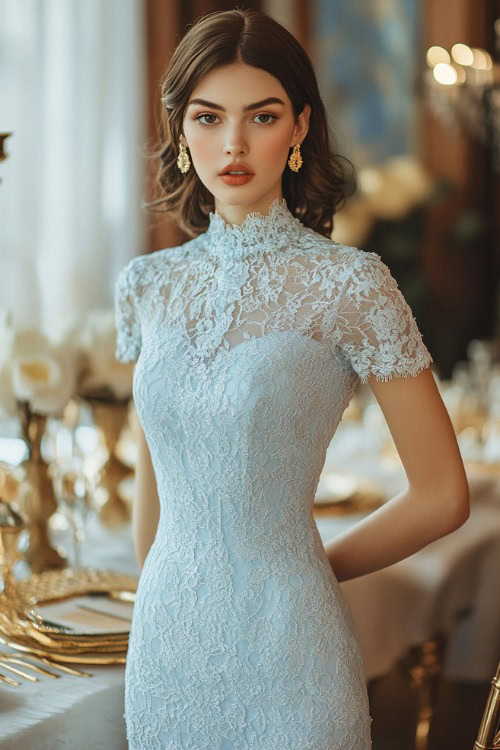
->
[[0, 0, 500, 750]]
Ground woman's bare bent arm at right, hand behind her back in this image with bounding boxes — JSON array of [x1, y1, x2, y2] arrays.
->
[[325, 367, 469, 582]]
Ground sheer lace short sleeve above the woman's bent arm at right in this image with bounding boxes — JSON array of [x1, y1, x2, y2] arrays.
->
[[335, 251, 433, 383]]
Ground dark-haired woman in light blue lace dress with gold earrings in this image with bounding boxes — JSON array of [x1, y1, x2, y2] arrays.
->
[[115, 10, 469, 750]]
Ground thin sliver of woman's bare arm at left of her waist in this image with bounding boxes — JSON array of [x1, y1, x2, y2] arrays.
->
[[132, 408, 160, 570]]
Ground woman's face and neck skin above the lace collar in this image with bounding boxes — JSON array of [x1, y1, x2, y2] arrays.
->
[[182, 63, 311, 224]]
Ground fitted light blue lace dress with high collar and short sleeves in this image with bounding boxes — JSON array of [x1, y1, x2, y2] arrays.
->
[[115, 199, 432, 750]]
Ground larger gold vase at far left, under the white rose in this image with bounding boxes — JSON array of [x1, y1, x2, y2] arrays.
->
[[18, 401, 66, 573]]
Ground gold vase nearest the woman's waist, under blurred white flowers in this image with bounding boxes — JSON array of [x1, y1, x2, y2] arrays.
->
[[86, 397, 131, 527]]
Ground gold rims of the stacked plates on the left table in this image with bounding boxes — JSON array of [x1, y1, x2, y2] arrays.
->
[[0, 568, 138, 664]]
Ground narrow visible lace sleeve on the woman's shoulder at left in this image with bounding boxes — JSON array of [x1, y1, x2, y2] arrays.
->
[[114, 258, 142, 362]]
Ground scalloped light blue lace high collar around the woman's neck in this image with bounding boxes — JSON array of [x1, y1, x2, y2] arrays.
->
[[204, 198, 304, 260]]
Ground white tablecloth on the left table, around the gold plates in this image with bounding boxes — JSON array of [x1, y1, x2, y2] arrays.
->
[[0, 520, 138, 750]]
